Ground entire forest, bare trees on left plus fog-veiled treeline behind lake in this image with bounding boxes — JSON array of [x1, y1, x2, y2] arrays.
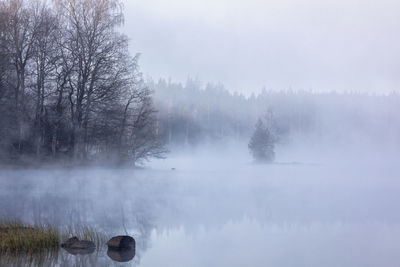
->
[[0, 0, 400, 168]]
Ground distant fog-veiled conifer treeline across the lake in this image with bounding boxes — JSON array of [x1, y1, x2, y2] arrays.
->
[[152, 79, 400, 148]]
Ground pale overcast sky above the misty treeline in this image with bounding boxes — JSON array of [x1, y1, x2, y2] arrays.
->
[[124, 0, 400, 94]]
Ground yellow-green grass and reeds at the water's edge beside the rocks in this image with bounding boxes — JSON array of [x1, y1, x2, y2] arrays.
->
[[0, 220, 106, 253]]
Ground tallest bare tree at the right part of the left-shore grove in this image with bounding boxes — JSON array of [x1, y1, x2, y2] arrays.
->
[[56, 0, 127, 158]]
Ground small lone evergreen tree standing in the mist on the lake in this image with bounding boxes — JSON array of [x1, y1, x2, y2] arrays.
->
[[248, 119, 275, 162]]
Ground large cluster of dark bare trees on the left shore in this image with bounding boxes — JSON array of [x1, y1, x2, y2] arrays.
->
[[0, 0, 165, 163]]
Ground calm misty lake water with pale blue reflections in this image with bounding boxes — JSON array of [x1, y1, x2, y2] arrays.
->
[[0, 143, 400, 266]]
